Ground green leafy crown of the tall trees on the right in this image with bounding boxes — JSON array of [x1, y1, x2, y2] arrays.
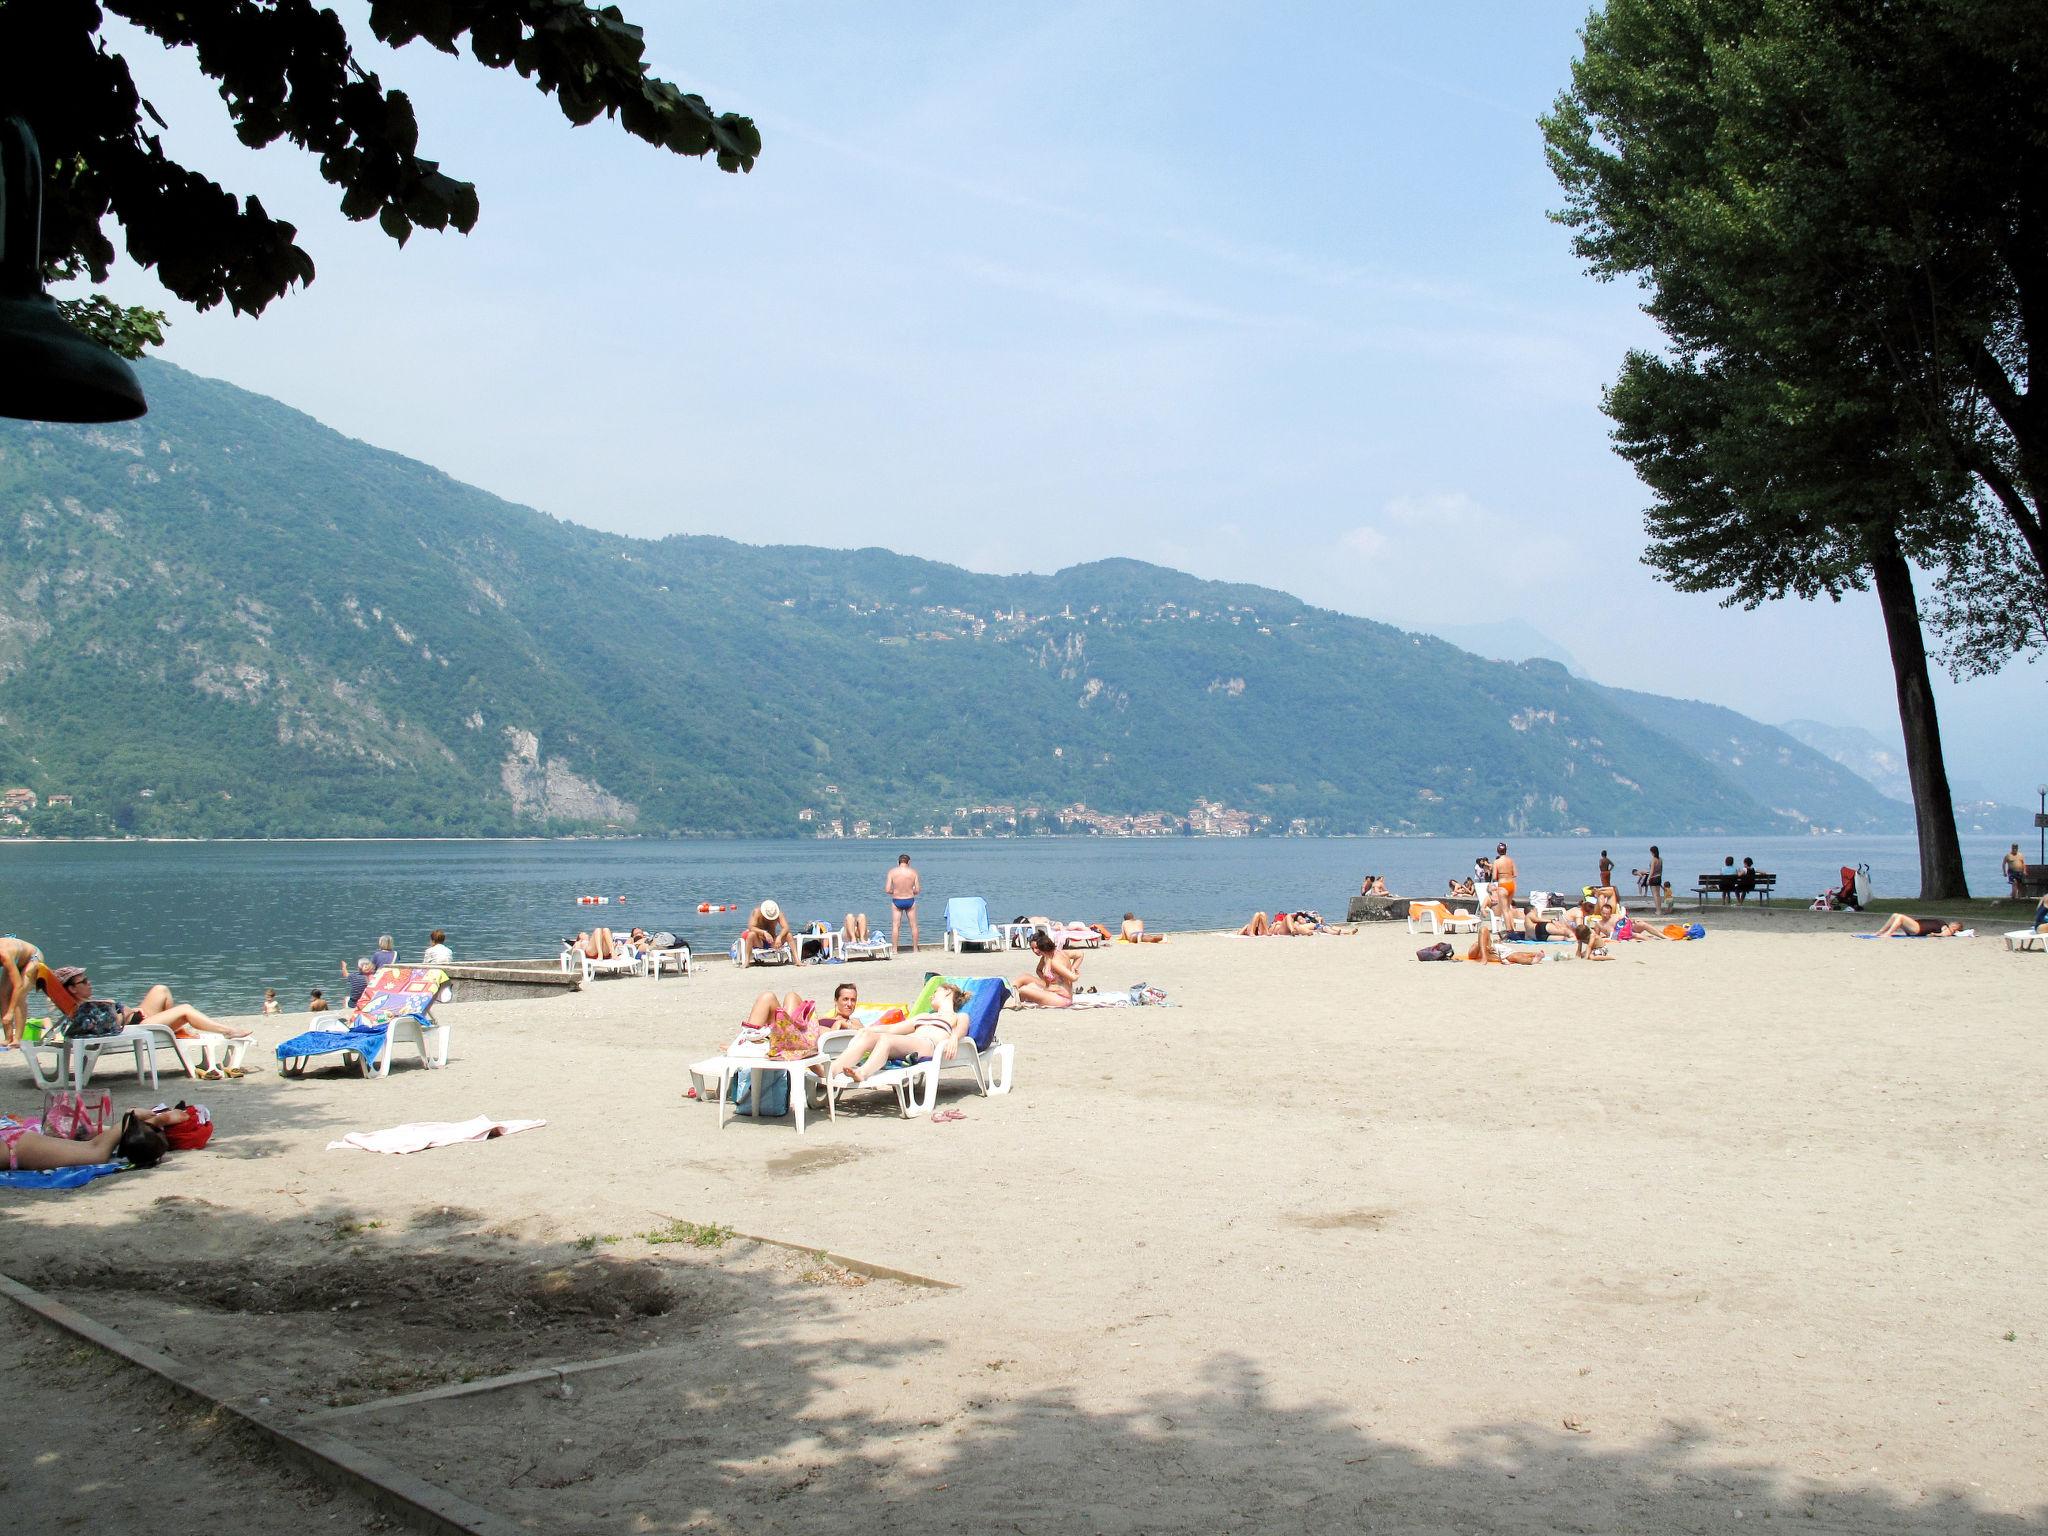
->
[[1544, 0, 2048, 668]]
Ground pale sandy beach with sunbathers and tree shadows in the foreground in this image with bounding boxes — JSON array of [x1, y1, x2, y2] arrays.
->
[[0, 911, 2048, 1532]]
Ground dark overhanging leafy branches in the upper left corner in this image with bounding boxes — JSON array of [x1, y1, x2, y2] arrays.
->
[[0, 0, 760, 325]]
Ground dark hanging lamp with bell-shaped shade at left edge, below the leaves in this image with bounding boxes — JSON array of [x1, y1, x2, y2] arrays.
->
[[0, 117, 150, 422]]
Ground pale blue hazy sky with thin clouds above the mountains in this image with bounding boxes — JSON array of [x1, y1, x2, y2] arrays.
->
[[72, 0, 2048, 809]]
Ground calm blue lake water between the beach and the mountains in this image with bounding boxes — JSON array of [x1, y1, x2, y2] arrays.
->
[[0, 836, 2009, 1014]]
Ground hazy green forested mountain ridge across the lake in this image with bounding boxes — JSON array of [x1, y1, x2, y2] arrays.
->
[[0, 362, 1911, 836]]
